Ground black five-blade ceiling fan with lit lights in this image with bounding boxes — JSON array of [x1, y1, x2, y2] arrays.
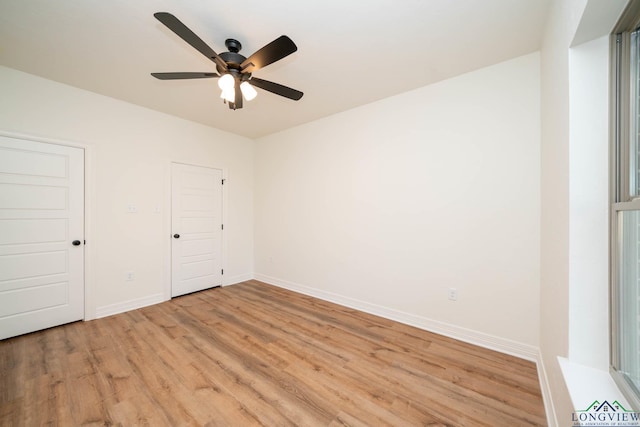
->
[[151, 12, 304, 110]]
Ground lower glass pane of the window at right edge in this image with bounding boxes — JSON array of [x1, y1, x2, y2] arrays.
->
[[616, 211, 640, 389]]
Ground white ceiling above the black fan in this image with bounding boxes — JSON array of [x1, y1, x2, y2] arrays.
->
[[0, 0, 550, 138]]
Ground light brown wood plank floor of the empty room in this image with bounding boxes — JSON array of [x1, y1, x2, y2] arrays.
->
[[0, 281, 545, 427]]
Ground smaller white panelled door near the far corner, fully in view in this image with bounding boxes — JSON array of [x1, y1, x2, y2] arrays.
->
[[171, 163, 223, 297]]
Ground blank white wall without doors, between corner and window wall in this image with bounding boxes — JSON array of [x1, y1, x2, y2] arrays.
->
[[255, 54, 540, 357]]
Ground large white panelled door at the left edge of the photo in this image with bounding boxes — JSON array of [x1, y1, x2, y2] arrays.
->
[[0, 136, 84, 339]]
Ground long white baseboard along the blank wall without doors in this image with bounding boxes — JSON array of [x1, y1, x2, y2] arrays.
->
[[255, 274, 539, 362]]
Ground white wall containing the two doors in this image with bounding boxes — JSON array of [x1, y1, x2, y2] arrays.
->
[[0, 67, 253, 318]]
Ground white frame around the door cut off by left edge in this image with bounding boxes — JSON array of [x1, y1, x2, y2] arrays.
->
[[0, 129, 96, 321]]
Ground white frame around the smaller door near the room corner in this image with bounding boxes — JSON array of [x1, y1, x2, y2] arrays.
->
[[163, 160, 229, 301]]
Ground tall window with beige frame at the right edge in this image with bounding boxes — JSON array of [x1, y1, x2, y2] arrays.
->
[[611, 0, 640, 407]]
